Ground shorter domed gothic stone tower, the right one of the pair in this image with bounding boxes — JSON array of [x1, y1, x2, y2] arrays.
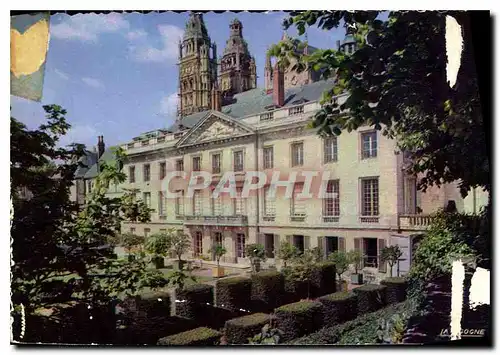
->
[[220, 19, 257, 96]]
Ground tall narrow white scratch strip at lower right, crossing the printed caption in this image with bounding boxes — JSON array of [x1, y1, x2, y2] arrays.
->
[[450, 260, 465, 340]]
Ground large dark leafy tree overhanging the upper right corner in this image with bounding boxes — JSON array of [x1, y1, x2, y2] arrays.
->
[[269, 11, 491, 196]]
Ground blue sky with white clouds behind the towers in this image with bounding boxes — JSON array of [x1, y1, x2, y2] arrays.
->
[[11, 12, 344, 146]]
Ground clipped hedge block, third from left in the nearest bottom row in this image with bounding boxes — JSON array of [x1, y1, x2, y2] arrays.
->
[[275, 301, 323, 341]]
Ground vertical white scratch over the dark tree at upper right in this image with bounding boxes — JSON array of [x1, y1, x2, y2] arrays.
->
[[446, 16, 463, 88]]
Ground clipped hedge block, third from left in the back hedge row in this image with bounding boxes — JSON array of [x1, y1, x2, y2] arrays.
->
[[215, 277, 252, 310]]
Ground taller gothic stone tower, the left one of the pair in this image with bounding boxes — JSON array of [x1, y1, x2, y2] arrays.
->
[[178, 12, 217, 119]]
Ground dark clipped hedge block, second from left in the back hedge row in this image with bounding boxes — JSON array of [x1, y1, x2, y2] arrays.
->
[[175, 284, 214, 319]]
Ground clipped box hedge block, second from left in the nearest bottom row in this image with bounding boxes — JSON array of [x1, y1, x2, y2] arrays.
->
[[225, 313, 271, 344]]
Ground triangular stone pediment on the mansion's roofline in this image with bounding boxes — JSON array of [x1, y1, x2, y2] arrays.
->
[[177, 111, 254, 147]]
